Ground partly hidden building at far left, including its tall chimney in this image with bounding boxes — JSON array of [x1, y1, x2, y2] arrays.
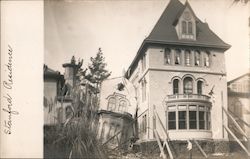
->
[[44, 56, 81, 125]]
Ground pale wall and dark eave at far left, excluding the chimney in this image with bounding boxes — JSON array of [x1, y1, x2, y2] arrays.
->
[[43, 65, 64, 125]]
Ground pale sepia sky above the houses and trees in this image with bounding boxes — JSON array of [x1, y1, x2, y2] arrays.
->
[[44, 0, 250, 81]]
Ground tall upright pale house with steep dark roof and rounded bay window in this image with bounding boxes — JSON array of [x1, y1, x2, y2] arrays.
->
[[126, 0, 230, 142]]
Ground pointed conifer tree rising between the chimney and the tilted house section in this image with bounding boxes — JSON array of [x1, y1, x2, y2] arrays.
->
[[86, 48, 111, 93]]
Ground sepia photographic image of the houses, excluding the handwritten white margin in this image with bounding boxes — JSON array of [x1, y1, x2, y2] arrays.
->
[[43, 0, 250, 159]]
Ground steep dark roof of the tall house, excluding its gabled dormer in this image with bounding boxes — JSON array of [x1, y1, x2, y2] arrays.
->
[[127, 0, 230, 77]]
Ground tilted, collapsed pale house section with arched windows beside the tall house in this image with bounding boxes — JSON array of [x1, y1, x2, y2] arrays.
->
[[98, 77, 136, 148]]
